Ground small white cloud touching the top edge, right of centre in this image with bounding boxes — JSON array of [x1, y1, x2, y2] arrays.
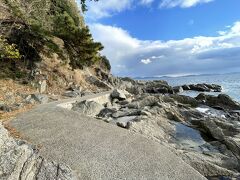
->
[[160, 0, 214, 8]]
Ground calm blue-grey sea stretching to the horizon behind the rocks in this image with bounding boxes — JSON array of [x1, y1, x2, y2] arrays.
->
[[137, 73, 240, 102]]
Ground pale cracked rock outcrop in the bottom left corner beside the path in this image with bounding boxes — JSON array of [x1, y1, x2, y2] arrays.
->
[[0, 124, 78, 180]]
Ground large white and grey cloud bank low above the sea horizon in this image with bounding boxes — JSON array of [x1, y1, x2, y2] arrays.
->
[[90, 22, 240, 76]]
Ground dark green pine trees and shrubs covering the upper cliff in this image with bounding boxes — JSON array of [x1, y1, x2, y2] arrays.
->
[[1, 0, 111, 71]]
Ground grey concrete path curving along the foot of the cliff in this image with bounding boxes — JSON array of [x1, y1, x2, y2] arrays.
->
[[10, 93, 205, 180]]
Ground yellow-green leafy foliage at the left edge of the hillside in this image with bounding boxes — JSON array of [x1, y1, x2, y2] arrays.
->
[[0, 36, 21, 60]]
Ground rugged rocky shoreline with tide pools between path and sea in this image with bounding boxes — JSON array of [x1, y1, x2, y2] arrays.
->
[[72, 78, 240, 179]]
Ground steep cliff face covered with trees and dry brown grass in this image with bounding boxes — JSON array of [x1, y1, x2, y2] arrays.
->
[[0, 0, 110, 93]]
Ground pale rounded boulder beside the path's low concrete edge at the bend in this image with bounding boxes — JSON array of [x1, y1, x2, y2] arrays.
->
[[72, 100, 104, 116]]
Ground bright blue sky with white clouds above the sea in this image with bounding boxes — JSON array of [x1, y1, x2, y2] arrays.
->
[[85, 0, 240, 77]]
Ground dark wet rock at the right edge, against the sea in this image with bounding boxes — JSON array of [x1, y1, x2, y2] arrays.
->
[[196, 93, 240, 110]]
